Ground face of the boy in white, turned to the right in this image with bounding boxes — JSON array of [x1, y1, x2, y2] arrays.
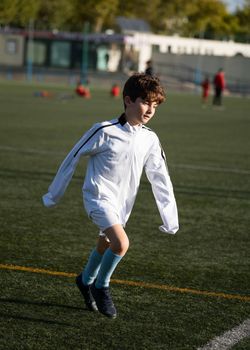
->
[[124, 96, 158, 125]]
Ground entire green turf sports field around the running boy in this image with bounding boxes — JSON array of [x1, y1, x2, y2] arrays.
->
[[0, 82, 250, 350]]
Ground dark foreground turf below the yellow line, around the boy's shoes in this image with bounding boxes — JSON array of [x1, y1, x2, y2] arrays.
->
[[1, 272, 247, 349]]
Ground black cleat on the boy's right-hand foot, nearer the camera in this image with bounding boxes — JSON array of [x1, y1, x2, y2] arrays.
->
[[90, 283, 116, 318]]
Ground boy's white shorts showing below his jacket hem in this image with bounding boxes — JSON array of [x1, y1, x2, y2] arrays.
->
[[89, 209, 121, 236]]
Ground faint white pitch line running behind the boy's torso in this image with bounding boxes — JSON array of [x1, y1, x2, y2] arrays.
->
[[0, 146, 250, 175]]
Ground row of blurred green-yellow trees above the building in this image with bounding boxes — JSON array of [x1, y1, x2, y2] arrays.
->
[[0, 0, 246, 41]]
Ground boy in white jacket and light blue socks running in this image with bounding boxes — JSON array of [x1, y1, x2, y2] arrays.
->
[[43, 73, 179, 318]]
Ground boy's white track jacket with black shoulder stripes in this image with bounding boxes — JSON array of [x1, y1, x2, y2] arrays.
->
[[43, 114, 179, 234]]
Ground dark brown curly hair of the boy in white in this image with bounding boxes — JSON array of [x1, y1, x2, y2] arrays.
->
[[123, 73, 166, 104]]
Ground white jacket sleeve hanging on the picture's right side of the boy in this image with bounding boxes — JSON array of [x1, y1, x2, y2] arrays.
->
[[145, 140, 179, 234]]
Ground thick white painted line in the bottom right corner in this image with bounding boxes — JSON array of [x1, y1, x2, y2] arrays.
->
[[197, 319, 250, 350]]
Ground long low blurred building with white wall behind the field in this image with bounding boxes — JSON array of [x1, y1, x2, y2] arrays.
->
[[0, 26, 250, 90]]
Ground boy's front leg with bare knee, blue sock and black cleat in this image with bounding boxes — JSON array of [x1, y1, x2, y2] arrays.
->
[[91, 225, 129, 317]]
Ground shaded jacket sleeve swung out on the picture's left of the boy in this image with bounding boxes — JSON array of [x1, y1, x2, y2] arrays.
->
[[42, 124, 102, 208]]
